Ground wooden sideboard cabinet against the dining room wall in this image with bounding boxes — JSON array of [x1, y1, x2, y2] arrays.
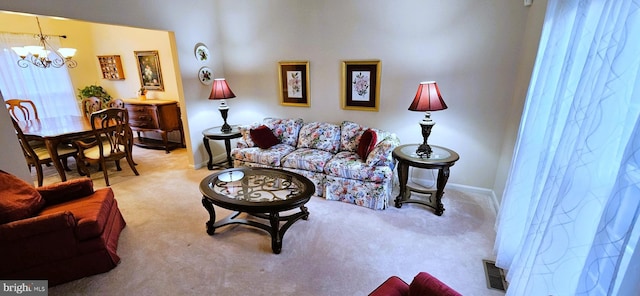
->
[[124, 99, 185, 153]]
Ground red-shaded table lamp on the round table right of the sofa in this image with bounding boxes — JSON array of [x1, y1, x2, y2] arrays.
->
[[409, 81, 447, 158]]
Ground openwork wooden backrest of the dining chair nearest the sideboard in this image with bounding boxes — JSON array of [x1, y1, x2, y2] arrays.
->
[[91, 108, 133, 158]]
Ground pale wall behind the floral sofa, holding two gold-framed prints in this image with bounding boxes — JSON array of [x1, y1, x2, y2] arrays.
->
[[216, 0, 531, 197]]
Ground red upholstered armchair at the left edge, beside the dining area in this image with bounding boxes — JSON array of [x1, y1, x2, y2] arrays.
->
[[0, 170, 126, 286]]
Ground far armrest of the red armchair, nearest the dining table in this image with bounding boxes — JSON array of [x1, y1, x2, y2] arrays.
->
[[36, 177, 94, 205]]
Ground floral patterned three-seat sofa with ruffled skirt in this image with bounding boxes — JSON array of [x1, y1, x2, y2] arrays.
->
[[231, 118, 400, 210]]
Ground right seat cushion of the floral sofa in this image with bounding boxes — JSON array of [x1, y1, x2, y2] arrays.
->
[[324, 151, 393, 182]]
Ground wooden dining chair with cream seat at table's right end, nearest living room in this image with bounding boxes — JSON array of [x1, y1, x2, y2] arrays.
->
[[75, 108, 140, 186]]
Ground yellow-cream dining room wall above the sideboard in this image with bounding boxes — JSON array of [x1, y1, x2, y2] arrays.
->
[[0, 13, 179, 100]]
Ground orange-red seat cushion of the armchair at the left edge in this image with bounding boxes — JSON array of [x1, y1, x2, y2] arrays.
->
[[39, 188, 114, 240]]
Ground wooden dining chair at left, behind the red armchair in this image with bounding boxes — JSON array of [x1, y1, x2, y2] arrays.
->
[[11, 118, 78, 186]]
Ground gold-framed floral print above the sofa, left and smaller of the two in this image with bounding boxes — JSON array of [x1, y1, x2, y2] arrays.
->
[[278, 61, 311, 107]]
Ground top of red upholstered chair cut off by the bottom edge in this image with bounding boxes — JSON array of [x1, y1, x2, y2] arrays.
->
[[369, 272, 462, 296]]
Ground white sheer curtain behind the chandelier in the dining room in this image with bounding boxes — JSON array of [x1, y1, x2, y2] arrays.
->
[[0, 33, 80, 118]]
